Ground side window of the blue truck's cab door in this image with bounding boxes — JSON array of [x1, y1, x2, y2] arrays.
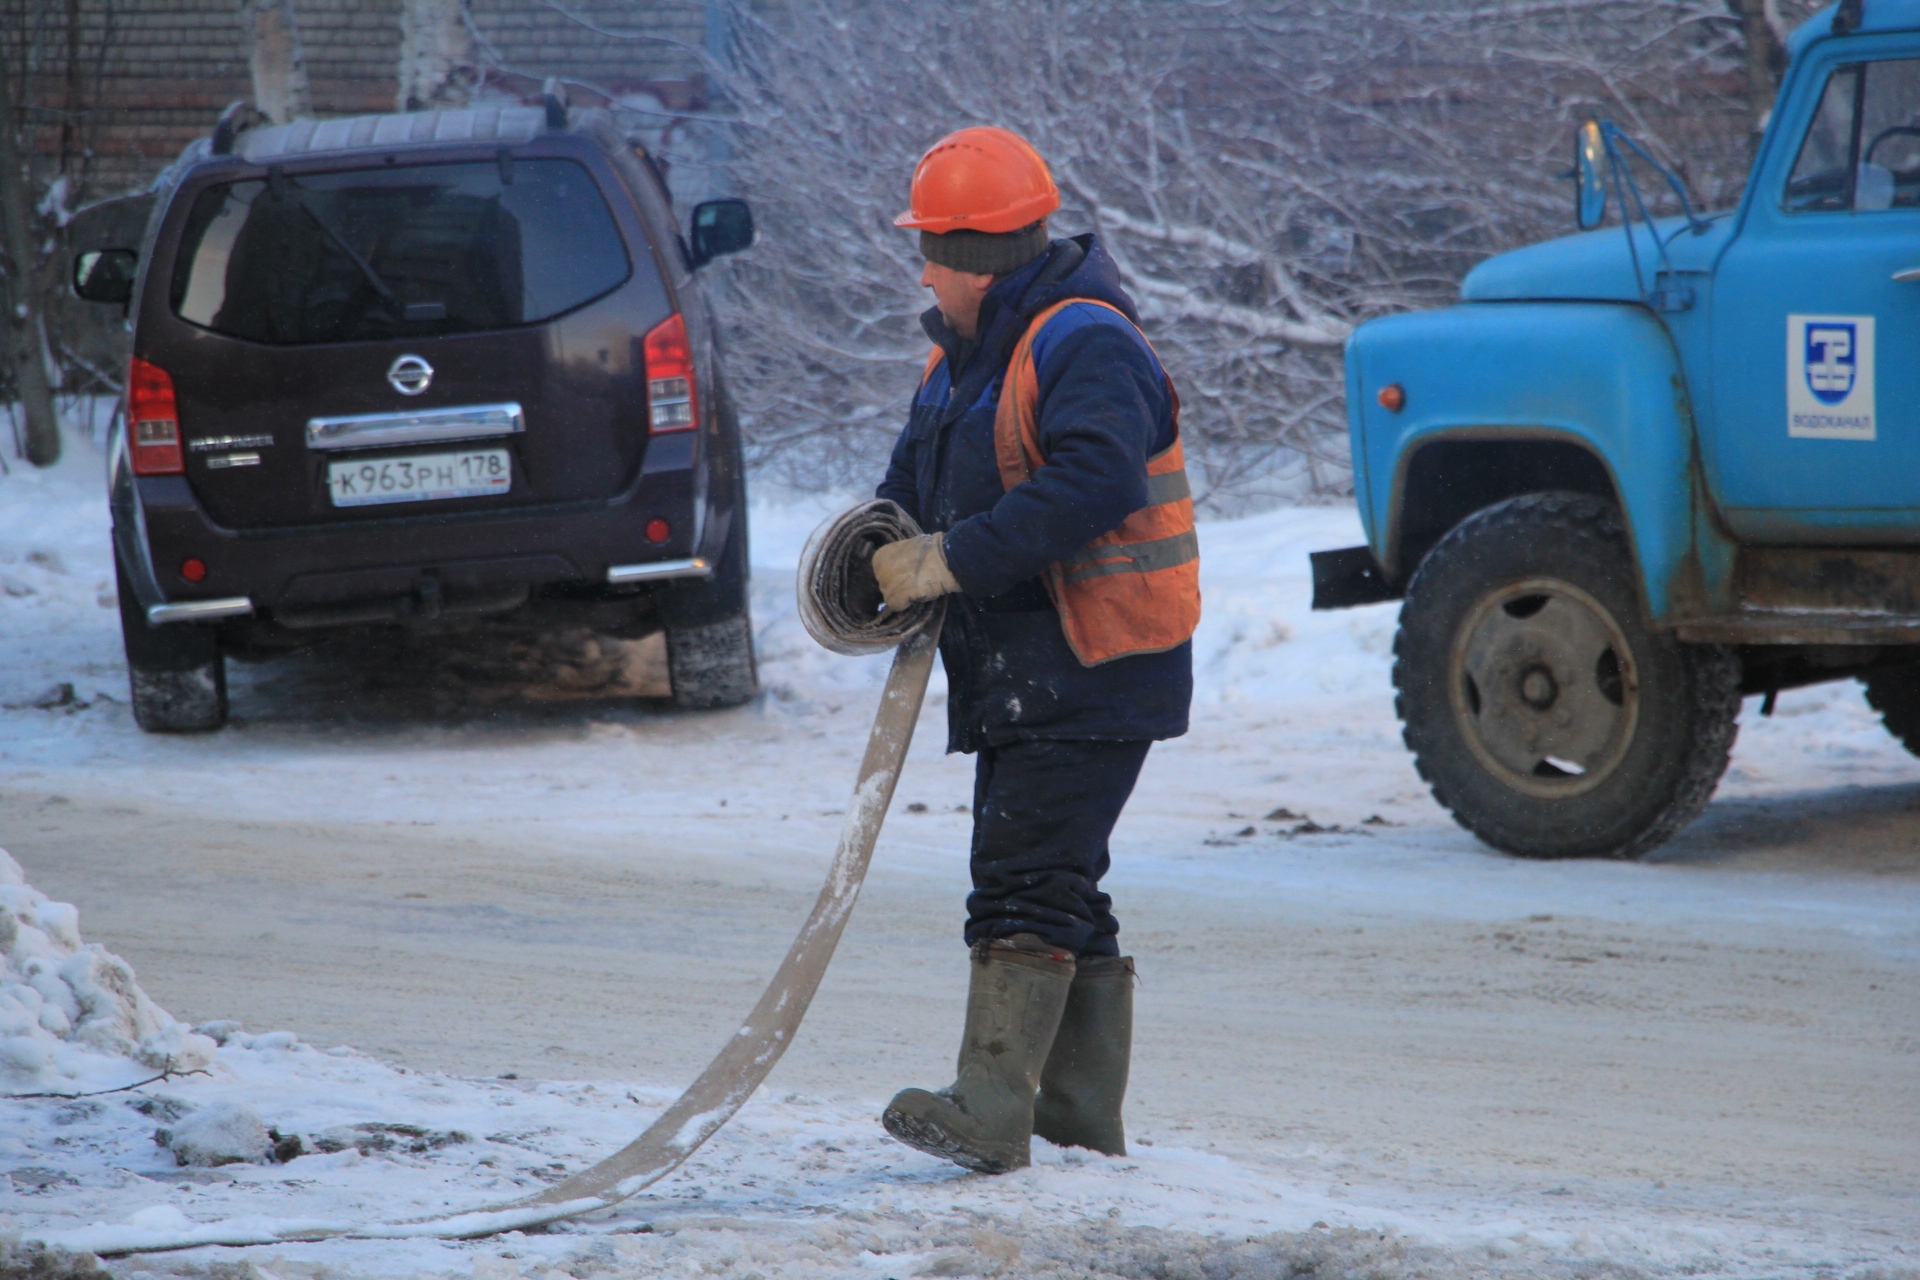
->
[[1782, 58, 1920, 213]]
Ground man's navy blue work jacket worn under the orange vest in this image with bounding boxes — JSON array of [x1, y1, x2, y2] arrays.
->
[[877, 236, 1192, 752]]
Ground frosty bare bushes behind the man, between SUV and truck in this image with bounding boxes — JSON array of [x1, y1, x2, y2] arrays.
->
[[518, 0, 1811, 509]]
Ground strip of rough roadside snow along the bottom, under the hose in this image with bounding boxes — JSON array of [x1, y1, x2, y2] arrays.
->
[[15, 1032, 1889, 1280]]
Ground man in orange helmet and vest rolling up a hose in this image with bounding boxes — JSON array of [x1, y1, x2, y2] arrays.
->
[[874, 129, 1200, 1173]]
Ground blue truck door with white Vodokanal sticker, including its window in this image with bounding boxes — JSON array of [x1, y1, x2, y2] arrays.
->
[[1705, 47, 1920, 543]]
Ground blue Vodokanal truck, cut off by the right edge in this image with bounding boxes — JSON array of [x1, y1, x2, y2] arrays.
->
[[1313, 0, 1920, 858]]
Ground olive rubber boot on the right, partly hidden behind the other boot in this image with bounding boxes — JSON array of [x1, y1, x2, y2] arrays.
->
[[1033, 956, 1133, 1155]]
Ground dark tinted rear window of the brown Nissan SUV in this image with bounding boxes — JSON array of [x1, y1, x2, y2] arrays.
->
[[173, 159, 632, 345]]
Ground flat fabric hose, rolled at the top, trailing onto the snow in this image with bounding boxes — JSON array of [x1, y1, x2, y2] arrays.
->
[[44, 501, 947, 1255]]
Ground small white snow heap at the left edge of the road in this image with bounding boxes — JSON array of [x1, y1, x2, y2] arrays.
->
[[0, 848, 213, 1094]]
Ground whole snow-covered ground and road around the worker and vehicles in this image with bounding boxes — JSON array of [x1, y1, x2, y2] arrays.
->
[[0, 443, 1920, 1280]]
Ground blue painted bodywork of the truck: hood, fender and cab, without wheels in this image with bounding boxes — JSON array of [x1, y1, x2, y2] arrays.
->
[[1346, 0, 1920, 624]]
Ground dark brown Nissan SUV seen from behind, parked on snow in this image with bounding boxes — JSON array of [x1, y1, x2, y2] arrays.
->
[[73, 98, 756, 731]]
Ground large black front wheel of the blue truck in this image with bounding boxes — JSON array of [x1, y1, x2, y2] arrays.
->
[[1394, 493, 1740, 858]]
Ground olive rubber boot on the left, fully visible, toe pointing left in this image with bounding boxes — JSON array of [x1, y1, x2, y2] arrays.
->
[[879, 935, 1073, 1173]]
